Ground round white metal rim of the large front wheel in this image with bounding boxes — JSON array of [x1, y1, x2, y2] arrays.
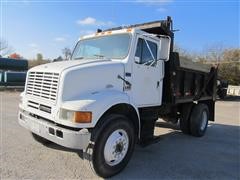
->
[[104, 129, 129, 166]]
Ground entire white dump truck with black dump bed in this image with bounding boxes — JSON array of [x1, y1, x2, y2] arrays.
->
[[18, 17, 217, 178]]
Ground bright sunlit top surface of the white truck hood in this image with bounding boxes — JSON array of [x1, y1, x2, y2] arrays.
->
[[30, 59, 112, 73]]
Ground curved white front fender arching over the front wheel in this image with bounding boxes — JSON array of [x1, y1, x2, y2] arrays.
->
[[61, 90, 138, 128]]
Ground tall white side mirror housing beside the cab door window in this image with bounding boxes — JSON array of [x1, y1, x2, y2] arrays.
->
[[159, 36, 171, 61]]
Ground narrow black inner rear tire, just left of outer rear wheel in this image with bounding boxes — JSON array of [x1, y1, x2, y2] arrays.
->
[[180, 104, 193, 134]]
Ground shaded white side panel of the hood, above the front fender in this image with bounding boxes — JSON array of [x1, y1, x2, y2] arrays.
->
[[59, 60, 124, 101]]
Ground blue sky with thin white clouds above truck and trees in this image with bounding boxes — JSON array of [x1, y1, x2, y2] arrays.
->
[[0, 0, 240, 59]]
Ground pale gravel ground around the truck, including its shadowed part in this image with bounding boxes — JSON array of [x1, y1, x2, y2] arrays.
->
[[0, 92, 240, 179]]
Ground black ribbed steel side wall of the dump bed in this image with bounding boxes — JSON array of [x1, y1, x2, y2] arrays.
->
[[163, 52, 217, 104]]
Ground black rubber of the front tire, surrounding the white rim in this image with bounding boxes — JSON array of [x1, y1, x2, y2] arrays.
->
[[86, 114, 135, 178]]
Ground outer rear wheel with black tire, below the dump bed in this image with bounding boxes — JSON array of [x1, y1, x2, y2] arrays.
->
[[190, 104, 209, 137]]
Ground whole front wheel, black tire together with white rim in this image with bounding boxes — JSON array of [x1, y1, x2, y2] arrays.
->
[[86, 114, 135, 178]]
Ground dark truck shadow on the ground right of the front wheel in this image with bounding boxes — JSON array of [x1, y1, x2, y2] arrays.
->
[[44, 122, 240, 179]]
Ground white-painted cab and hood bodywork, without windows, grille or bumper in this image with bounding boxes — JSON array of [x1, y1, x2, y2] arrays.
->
[[20, 29, 170, 149]]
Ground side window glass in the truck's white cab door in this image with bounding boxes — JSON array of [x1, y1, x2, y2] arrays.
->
[[135, 38, 157, 64]]
